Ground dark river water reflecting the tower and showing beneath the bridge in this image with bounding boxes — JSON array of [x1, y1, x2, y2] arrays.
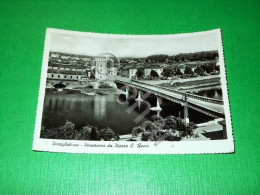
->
[[42, 88, 221, 135]]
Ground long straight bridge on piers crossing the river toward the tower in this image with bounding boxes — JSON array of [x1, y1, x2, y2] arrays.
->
[[114, 77, 224, 118]]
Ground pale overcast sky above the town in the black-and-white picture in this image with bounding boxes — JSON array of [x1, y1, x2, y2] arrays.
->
[[50, 31, 219, 57]]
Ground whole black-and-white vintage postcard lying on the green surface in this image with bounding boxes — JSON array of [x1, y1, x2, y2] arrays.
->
[[33, 29, 234, 154]]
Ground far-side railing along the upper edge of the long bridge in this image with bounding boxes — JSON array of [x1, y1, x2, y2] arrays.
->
[[116, 79, 223, 105]]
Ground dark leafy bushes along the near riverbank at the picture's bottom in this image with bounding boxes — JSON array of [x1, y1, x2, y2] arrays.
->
[[40, 116, 199, 141]]
